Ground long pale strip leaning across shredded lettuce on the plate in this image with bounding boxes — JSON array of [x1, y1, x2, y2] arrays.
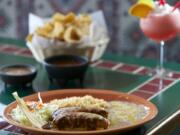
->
[[12, 92, 46, 128]]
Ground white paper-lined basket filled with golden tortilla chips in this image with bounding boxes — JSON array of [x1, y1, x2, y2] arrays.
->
[[26, 11, 109, 62]]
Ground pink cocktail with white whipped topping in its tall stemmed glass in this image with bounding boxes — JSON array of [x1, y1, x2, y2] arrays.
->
[[140, 2, 180, 77]]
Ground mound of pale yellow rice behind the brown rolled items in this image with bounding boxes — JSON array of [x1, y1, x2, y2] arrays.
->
[[50, 95, 109, 109]]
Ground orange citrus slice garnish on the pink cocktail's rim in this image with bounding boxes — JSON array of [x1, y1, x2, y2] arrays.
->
[[129, 0, 154, 18]]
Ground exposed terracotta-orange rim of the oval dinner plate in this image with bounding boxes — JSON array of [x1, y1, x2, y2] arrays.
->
[[3, 89, 158, 135]]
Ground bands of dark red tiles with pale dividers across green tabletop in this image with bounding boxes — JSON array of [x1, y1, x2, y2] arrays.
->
[[0, 45, 180, 99]]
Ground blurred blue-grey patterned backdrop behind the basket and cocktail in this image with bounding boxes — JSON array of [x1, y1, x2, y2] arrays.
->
[[0, 0, 180, 62]]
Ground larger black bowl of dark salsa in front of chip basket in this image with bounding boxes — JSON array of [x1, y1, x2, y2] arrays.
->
[[44, 55, 89, 81]]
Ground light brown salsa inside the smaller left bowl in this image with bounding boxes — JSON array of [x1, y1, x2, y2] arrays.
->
[[3, 67, 32, 75]]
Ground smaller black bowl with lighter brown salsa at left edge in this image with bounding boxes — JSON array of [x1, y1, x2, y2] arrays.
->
[[0, 64, 37, 85]]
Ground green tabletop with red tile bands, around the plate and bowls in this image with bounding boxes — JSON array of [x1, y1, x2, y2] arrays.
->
[[0, 38, 180, 135]]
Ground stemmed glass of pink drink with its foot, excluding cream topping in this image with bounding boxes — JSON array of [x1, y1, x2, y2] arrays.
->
[[140, 11, 180, 78]]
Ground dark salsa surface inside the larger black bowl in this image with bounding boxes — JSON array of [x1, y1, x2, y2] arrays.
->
[[50, 59, 82, 66]]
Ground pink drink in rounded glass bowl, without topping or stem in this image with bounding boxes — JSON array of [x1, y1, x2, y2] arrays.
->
[[140, 13, 180, 42]]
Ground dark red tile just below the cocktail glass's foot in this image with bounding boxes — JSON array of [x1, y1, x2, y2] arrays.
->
[[139, 84, 163, 93]]
